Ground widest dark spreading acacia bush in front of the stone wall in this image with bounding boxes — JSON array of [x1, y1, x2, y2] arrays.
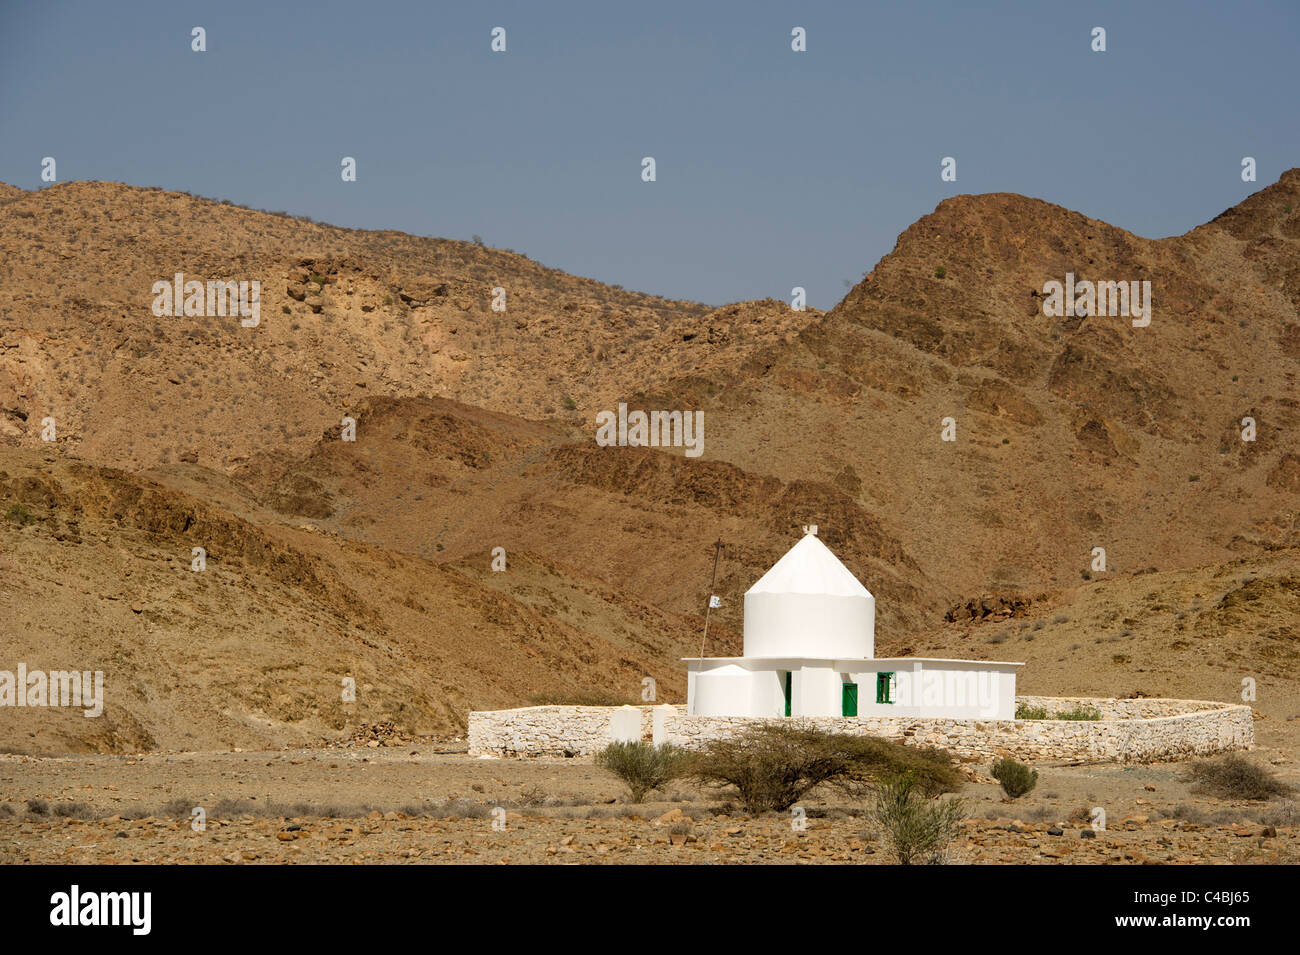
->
[[690, 724, 961, 812]]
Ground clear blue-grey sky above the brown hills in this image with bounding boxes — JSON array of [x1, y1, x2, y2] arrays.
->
[[0, 0, 1300, 308]]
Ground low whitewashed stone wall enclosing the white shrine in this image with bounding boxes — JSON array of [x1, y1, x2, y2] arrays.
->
[[469, 696, 1255, 763]]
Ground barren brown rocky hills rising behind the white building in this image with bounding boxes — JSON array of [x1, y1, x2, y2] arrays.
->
[[0, 170, 1300, 751]]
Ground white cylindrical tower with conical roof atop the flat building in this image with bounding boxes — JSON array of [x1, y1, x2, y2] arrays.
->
[[745, 533, 876, 660]]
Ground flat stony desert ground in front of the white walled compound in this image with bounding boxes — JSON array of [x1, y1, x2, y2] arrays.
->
[[0, 739, 1300, 865]]
